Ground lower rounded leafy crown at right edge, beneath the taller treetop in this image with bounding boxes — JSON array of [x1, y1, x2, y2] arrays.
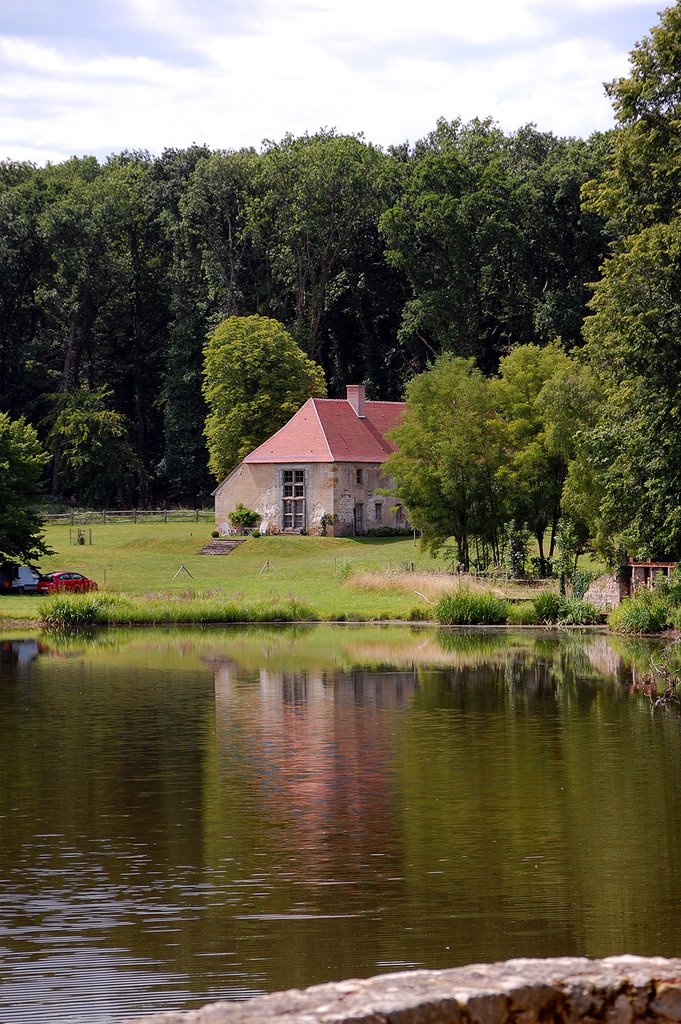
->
[[566, 219, 681, 559]]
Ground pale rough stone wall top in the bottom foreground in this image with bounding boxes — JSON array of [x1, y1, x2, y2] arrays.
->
[[128, 955, 681, 1024]]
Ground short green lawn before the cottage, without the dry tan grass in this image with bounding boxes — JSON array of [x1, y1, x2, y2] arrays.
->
[[0, 523, 444, 620]]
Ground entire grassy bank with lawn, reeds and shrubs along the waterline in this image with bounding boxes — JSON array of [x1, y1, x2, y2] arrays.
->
[[0, 522, 681, 634]]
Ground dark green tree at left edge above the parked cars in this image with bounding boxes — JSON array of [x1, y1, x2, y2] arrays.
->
[[0, 413, 50, 562]]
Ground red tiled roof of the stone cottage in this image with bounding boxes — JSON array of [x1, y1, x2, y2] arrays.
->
[[244, 398, 405, 463]]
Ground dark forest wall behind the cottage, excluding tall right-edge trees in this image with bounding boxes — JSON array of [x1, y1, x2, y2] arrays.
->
[[0, 121, 609, 504]]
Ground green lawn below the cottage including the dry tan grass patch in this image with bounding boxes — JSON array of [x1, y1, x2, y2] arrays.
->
[[0, 523, 557, 622]]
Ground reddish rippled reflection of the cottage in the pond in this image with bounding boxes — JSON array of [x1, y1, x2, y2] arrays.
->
[[215, 664, 417, 878]]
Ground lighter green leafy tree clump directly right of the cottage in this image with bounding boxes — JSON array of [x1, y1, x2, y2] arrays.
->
[[386, 345, 592, 574]]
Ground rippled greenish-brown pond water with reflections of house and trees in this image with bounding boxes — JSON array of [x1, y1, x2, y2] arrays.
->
[[0, 626, 681, 1024]]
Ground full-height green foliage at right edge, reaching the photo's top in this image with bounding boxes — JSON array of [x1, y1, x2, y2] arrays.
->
[[565, 2, 681, 561]]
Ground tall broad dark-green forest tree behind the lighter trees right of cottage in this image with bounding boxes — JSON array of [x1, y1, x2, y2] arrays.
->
[[380, 121, 603, 372]]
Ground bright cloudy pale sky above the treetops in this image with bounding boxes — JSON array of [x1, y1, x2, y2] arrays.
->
[[0, 0, 664, 165]]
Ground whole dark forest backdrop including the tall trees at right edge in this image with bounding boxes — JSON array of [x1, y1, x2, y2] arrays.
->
[[0, 2, 681, 565]]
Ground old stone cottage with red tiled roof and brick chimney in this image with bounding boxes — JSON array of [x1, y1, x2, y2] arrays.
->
[[214, 384, 409, 537]]
